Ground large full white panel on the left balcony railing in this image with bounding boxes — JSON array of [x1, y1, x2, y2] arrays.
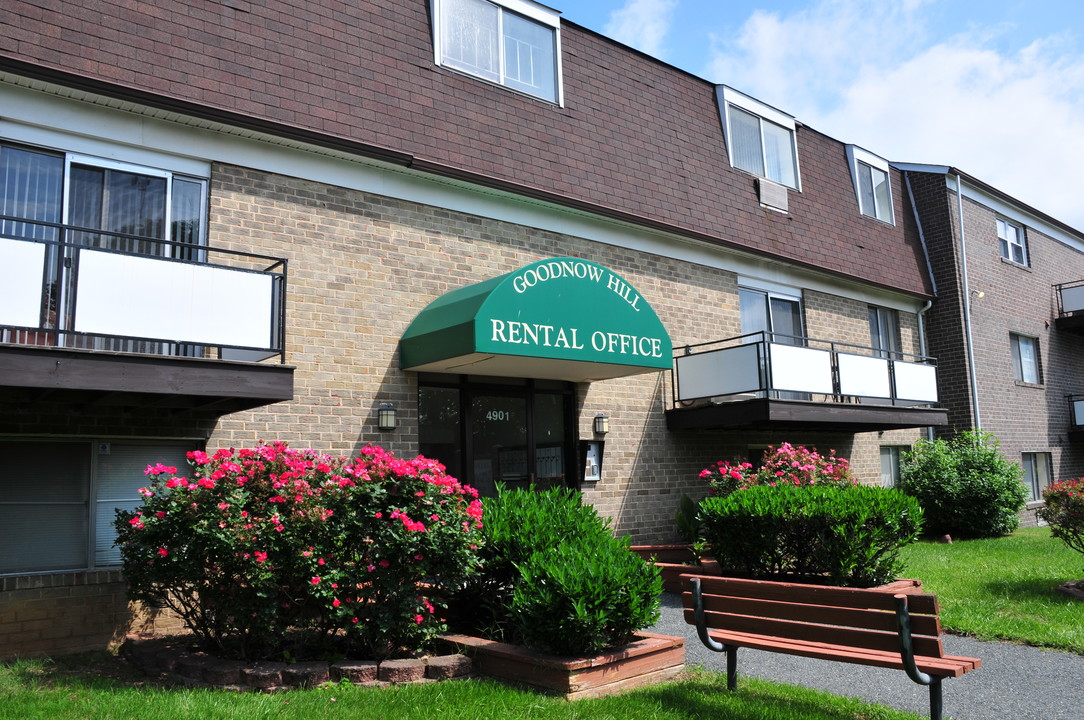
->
[[75, 250, 272, 348]]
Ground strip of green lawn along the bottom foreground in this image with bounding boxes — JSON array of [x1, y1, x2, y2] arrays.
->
[[0, 655, 918, 720]]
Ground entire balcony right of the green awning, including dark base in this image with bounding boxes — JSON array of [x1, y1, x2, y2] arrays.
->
[[667, 333, 949, 433]]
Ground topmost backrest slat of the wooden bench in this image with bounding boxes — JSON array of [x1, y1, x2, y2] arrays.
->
[[681, 574, 941, 615]]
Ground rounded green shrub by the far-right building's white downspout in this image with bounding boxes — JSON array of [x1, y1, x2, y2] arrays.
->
[[899, 430, 1028, 538]]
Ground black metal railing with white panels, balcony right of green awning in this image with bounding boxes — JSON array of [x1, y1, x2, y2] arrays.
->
[[672, 333, 938, 408]]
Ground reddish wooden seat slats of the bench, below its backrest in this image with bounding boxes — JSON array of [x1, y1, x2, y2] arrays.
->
[[709, 630, 982, 678]]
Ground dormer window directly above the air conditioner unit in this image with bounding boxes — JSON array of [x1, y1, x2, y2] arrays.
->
[[718, 86, 801, 190]]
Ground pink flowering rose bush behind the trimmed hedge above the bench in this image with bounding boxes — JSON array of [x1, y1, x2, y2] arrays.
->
[[700, 442, 856, 496]]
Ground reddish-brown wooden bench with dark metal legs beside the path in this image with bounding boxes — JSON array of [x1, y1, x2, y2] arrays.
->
[[682, 575, 982, 720]]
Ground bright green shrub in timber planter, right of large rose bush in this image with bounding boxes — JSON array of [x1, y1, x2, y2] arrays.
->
[[451, 488, 662, 654]]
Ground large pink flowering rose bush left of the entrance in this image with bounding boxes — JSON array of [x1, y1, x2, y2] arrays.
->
[[116, 442, 482, 659]]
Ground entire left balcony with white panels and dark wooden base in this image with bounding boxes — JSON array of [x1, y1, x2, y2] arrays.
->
[[0, 216, 294, 415]]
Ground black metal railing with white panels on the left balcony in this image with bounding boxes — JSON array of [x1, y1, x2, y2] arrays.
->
[[0, 216, 286, 363]]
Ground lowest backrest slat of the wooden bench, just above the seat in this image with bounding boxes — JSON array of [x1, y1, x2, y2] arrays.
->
[[685, 607, 944, 657]]
